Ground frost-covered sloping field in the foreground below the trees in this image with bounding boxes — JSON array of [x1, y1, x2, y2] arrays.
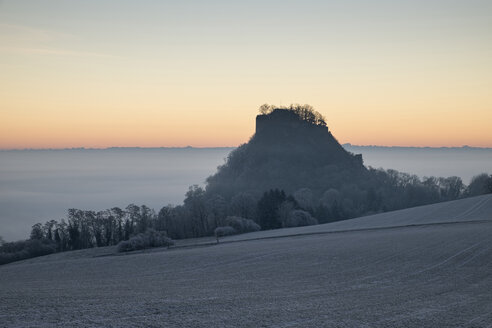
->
[[0, 195, 492, 327]]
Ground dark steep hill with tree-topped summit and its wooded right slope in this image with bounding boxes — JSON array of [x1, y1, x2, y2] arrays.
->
[[206, 105, 484, 224]]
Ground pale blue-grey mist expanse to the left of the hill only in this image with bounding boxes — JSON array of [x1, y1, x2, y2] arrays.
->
[[0, 148, 231, 241]]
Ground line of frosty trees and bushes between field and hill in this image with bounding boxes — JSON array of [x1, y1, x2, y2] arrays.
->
[[0, 169, 492, 264]]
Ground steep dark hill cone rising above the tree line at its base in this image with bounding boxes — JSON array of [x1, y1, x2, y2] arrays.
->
[[207, 109, 367, 199]]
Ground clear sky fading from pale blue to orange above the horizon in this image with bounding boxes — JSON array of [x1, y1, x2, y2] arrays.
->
[[0, 0, 492, 149]]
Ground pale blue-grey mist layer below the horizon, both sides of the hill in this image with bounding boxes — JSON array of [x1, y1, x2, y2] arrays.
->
[[0, 145, 492, 241]]
